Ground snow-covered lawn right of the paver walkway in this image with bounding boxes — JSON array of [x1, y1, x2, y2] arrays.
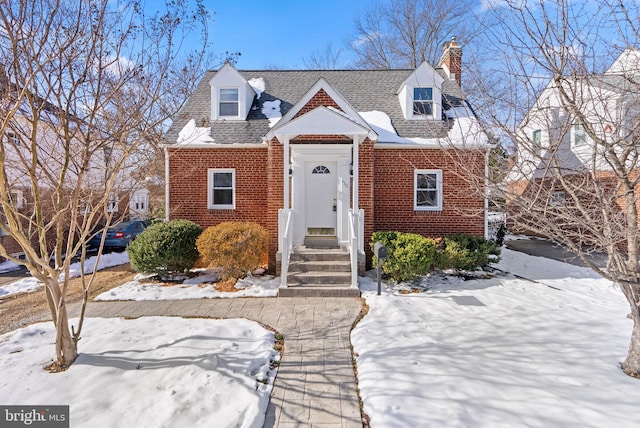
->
[[352, 249, 640, 428]]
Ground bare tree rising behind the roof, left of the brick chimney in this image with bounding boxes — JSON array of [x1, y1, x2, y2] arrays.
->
[[350, 0, 479, 68]]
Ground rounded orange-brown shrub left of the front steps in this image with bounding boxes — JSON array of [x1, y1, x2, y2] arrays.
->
[[196, 222, 269, 278]]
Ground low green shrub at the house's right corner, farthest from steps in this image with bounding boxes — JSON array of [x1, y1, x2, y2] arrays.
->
[[437, 234, 500, 270]]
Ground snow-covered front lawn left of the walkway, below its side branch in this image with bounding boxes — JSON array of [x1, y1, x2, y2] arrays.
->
[[0, 317, 278, 427]]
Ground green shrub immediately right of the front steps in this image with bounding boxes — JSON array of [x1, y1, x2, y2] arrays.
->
[[371, 232, 436, 282]]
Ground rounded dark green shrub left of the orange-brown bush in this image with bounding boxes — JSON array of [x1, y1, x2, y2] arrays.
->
[[127, 220, 202, 277]]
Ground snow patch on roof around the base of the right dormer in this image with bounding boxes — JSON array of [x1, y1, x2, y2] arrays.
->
[[358, 107, 489, 147]]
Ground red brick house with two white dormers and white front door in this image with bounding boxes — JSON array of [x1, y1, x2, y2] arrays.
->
[[165, 39, 488, 294]]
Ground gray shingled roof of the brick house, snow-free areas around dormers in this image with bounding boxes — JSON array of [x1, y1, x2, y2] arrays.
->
[[165, 69, 465, 144]]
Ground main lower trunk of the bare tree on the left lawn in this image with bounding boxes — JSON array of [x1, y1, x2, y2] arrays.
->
[[46, 279, 78, 370]]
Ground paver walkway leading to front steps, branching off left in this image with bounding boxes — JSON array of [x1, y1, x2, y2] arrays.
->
[[70, 297, 362, 428]]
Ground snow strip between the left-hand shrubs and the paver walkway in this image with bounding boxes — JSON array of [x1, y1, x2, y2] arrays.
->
[[94, 269, 280, 301]]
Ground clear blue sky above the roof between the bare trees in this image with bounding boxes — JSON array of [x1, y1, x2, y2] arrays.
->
[[204, 0, 373, 69]]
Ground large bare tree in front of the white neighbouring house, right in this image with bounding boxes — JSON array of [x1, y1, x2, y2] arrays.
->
[[468, 0, 640, 377]]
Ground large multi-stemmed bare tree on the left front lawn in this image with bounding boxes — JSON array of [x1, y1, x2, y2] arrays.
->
[[0, 0, 207, 369]]
